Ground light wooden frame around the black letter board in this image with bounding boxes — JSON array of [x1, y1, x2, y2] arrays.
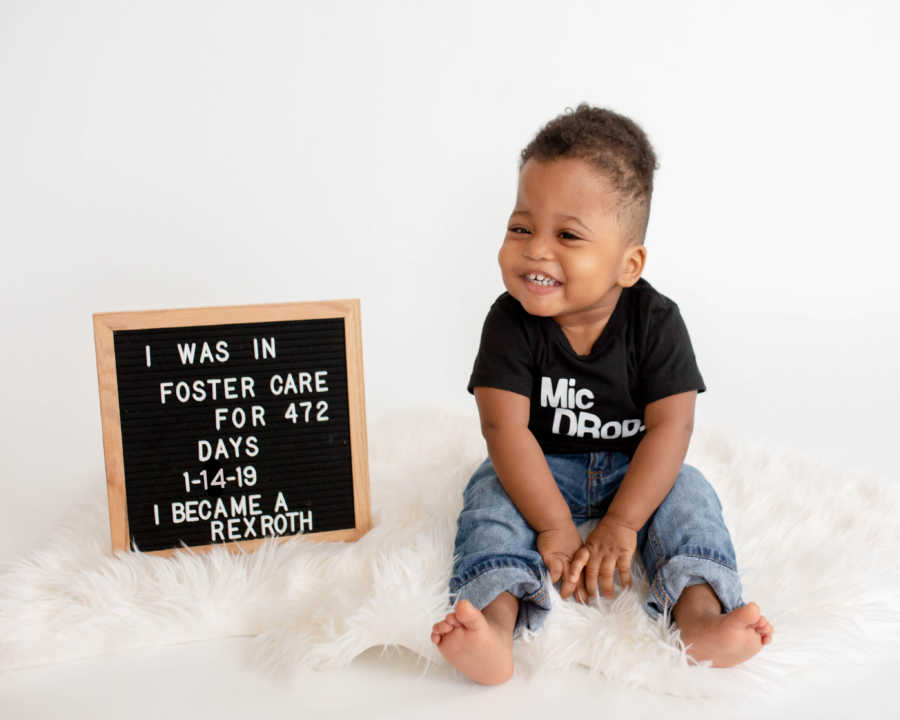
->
[[93, 299, 371, 556]]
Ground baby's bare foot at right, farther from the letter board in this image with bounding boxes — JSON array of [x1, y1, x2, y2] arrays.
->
[[678, 602, 775, 667]]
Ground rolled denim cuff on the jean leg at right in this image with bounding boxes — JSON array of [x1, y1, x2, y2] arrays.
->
[[644, 555, 746, 624]]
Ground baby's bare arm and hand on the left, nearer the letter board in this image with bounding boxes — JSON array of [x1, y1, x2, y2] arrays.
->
[[474, 387, 587, 601]]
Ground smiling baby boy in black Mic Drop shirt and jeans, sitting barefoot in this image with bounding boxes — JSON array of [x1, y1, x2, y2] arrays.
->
[[431, 104, 773, 685]]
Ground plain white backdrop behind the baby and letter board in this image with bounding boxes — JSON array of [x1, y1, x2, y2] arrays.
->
[[0, 1, 900, 559]]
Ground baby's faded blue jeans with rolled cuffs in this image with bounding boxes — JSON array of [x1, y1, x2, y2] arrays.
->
[[450, 452, 745, 637]]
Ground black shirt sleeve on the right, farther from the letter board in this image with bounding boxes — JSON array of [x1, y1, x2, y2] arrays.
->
[[640, 302, 706, 403]]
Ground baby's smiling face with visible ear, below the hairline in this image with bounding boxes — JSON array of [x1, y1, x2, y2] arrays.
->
[[498, 158, 644, 325]]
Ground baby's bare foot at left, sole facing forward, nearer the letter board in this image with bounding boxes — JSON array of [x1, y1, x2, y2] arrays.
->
[[431, 599, 513, 685]]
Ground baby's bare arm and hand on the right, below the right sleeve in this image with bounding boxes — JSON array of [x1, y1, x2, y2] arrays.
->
[[568, 391, 697, 597]]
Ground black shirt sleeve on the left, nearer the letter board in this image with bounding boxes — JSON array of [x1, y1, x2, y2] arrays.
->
[[467, 296, 533, 397]]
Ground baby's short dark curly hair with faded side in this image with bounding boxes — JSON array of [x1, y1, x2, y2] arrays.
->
[[519, 103, 658, 244]]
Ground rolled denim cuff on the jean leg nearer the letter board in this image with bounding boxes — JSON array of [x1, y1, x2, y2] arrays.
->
[[450, 558, 550, 638]]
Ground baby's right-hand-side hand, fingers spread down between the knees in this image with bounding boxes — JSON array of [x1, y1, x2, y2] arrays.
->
[[568, 516, 637, 598]]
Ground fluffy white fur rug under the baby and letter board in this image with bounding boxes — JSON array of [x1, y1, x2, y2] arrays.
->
[[0, 408, 900, 696]]
